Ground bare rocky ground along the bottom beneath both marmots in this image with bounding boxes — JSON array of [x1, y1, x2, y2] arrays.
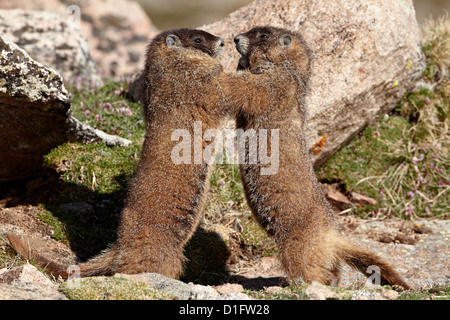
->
[[0, 205, 450, 300]]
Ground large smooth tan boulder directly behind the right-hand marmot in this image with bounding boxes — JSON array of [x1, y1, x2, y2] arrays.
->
[[201, 0, 425, 166]]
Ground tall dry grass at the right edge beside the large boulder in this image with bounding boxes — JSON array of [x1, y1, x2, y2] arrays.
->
[[370, 14, 450, 218]]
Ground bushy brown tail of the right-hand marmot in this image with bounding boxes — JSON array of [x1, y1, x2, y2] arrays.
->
[[335, 237, 410, 290]]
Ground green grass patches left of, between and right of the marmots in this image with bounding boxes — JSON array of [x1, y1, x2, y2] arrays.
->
[[37, 15, 450, 238]]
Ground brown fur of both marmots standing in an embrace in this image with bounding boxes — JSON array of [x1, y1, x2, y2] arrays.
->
[[8, 27, 408, 288]]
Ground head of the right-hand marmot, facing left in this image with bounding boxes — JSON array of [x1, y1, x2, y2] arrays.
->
[[234, 26, 311, 75]]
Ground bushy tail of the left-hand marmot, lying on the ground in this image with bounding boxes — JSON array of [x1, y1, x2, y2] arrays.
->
[[6, 232, 115, 279]]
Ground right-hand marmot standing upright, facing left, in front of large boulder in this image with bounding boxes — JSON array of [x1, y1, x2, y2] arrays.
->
[[225, 27, 409, 289]]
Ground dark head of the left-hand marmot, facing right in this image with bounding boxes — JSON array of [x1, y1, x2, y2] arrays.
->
[[150, 28, 224, 58]]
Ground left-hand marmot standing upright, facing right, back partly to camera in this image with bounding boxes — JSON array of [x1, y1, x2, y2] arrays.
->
[[8, 29, 224, 278]]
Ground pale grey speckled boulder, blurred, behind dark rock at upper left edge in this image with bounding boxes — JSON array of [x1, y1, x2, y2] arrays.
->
[[0, 10, 102, 86]]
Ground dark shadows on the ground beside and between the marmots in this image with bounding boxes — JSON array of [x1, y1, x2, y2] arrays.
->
[[0, 171, 243, 285]]
